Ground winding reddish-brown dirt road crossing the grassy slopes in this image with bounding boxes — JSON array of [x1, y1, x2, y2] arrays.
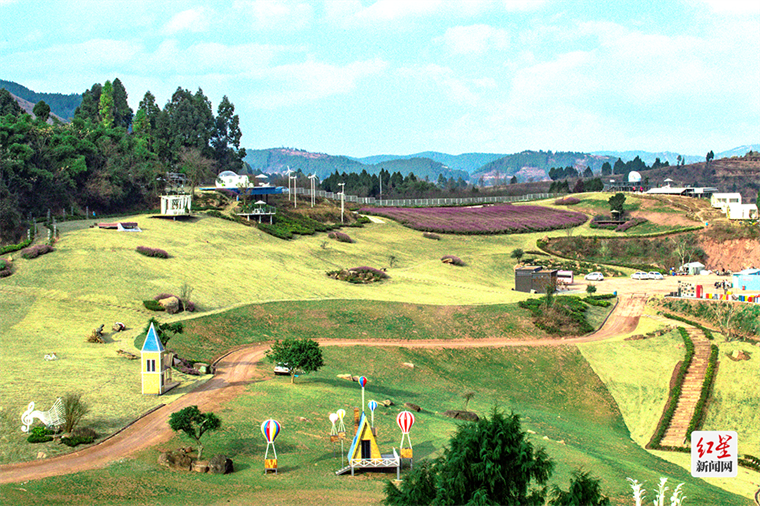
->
[[0, 295, 647, 483]]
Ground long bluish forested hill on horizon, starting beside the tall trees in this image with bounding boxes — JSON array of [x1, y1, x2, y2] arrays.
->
[[244, 148, 468, 182]]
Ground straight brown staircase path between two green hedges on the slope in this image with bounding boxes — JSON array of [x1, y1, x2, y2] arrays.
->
[[660, 327, 710, 446]]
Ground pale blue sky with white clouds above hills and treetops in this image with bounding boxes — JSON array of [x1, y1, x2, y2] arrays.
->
[[0, 0, 760, 156]]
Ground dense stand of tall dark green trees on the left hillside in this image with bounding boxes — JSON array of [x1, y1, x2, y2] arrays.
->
[[0, 79, 245, 241]]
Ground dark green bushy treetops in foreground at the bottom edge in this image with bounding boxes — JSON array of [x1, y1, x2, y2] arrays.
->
[[385, 410, 610, 506]]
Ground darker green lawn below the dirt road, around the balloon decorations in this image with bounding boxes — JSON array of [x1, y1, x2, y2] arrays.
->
[[0, 347, 746, 505]]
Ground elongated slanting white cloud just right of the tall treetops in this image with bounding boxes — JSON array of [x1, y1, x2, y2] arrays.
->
[[249, 59, 388, 109]]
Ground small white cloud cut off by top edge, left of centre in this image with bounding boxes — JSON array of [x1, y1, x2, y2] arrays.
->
[[233, 0, 314, 31]]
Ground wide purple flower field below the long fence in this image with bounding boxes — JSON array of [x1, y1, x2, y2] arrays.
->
[[360, 204, 587, 234]]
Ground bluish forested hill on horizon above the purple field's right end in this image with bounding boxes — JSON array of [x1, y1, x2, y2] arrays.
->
[[473, 151, 616, 178]]
